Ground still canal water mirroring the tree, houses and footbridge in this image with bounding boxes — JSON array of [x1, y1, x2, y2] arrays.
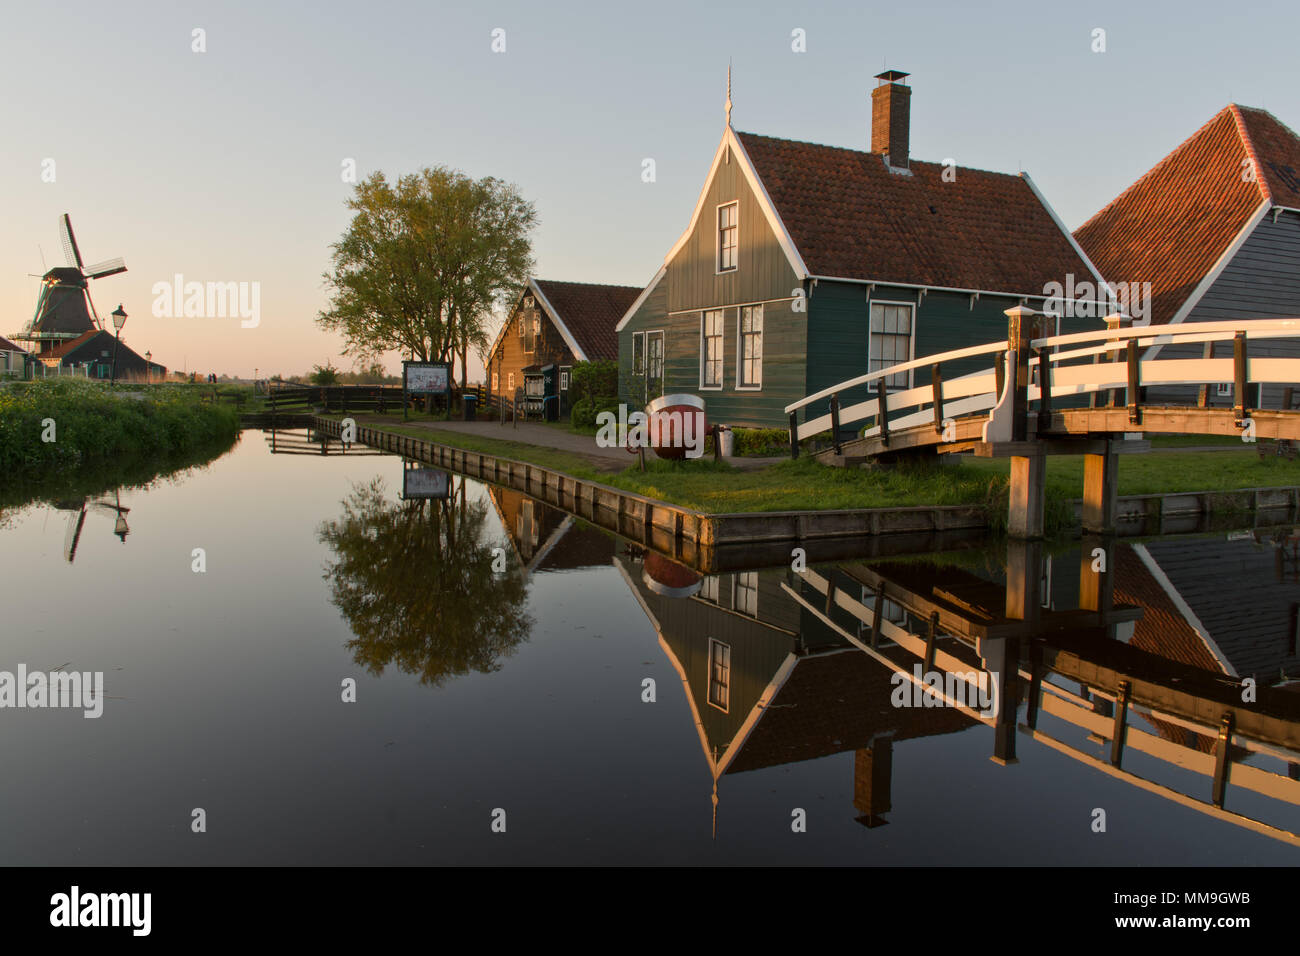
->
[[0, 432, 1300, 865]]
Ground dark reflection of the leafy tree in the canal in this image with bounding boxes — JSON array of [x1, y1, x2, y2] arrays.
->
[[320, 479, 532, 685]]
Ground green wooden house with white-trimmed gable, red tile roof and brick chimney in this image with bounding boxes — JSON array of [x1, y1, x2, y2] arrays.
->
[[618, 70, 1105, 428]]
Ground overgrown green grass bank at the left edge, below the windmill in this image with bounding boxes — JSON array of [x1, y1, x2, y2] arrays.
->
[[0, 378, 239, 485]]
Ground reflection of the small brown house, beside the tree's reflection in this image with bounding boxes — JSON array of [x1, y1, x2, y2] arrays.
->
[[488, 485, 615, 572]]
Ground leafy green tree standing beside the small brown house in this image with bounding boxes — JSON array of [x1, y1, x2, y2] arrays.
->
[[317, 166, 537, 390]]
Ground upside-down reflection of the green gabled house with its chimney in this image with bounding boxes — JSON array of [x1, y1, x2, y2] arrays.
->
[[615, 554, 975, 826]]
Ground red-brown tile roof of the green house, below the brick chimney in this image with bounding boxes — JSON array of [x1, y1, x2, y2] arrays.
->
[[736, 133, 1092, 295]]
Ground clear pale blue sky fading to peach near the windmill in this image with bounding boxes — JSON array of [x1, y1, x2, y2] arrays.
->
[[0, 0, 1300, 376]]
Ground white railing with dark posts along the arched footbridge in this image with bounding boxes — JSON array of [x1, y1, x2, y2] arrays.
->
[[785, 307, 1300, 457]]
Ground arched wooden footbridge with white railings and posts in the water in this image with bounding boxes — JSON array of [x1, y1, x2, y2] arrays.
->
[[785, 307, 1300, 537]]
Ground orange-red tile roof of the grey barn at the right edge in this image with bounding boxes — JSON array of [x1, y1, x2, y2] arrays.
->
[[1075, 104, 1300, 324]]
